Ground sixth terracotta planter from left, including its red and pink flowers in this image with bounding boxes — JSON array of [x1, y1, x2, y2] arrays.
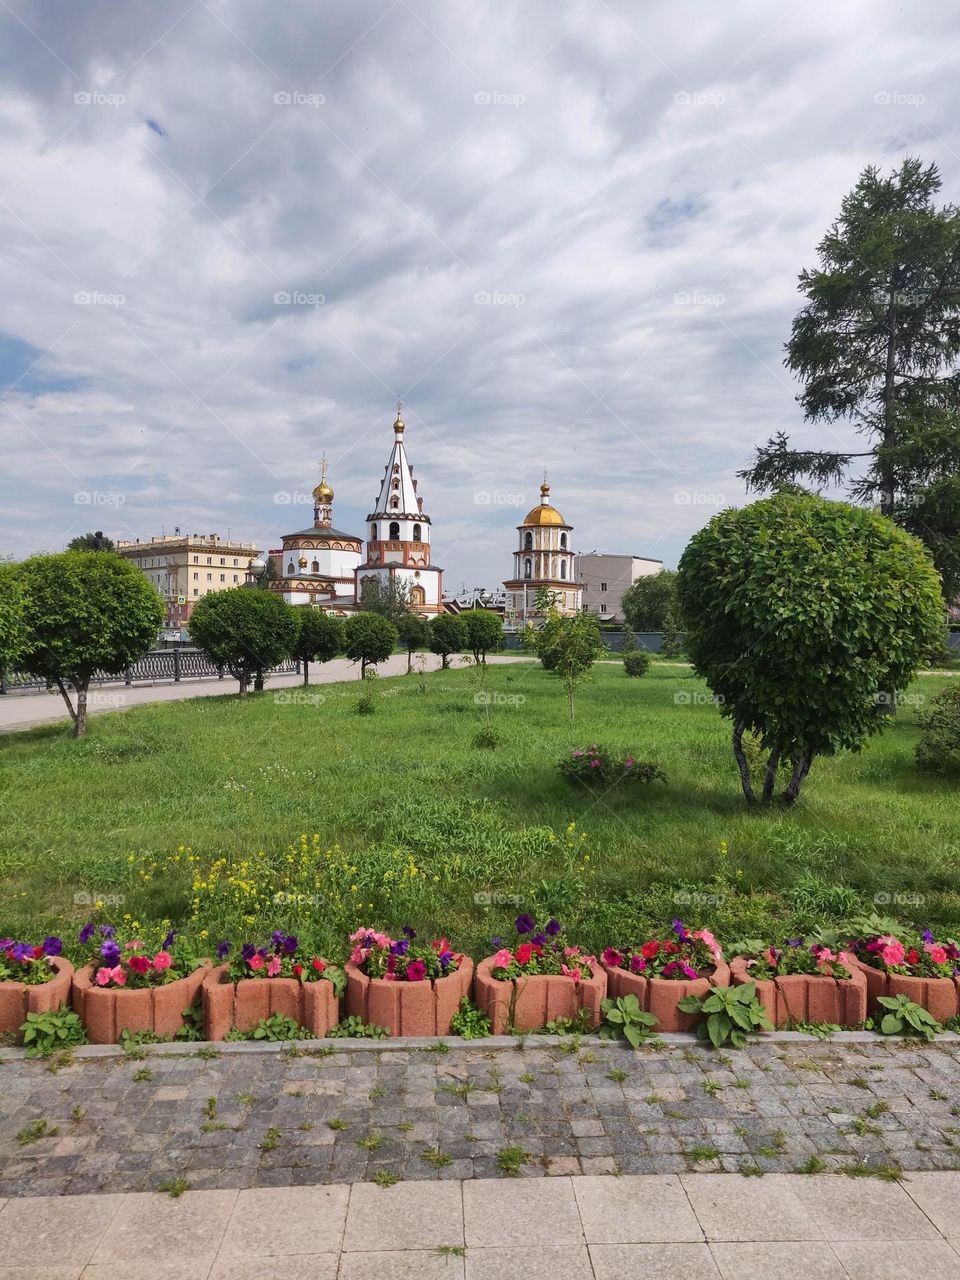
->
[[602, 920, 730, 1032]]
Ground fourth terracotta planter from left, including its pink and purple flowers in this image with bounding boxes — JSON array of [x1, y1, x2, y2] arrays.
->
[[346, 928, 474, 1036]]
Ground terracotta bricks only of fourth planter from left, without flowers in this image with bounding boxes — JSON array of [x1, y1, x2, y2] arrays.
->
[[344, 956, 474, 1036]]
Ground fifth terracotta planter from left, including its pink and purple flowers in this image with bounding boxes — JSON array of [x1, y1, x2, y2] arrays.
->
[[474, 915, 607, 1036]]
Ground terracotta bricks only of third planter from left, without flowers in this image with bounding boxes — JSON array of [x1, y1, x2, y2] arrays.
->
[[200, 964, 340, 1041]]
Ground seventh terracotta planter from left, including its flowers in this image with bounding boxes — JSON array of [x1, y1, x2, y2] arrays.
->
[[730, 938, 867, 1027]]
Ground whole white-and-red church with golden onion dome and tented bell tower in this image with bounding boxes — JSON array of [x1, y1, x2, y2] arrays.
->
[[270, 404, 443, 616]]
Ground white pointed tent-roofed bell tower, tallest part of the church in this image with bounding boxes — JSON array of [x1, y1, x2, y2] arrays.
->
[[355, 406, 443, 614]]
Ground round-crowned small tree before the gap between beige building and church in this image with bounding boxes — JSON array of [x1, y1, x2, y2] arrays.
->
[[189, 586, 297, 694]]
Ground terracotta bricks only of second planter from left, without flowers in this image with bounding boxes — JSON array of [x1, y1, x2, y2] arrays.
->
[[72, 960, 210, 1044]]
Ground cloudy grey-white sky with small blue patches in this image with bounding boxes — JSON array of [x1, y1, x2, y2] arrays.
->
[[0, 0, 960, 591]]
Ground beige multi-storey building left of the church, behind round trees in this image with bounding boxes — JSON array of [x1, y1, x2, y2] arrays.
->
[[116, 534, 259, 627]]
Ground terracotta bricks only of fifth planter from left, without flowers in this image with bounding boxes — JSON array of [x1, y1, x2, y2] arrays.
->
[[474, 956, 607, 1036]]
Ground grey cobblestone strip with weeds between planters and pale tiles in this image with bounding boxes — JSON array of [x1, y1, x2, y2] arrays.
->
[[0, 1038, 960, 1197]]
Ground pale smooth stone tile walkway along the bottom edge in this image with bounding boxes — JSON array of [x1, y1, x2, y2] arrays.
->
[[0, 1172, 960, 1280]]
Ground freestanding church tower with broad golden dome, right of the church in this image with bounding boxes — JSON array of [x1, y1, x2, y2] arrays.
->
[[503, 475, 584, 626]]
